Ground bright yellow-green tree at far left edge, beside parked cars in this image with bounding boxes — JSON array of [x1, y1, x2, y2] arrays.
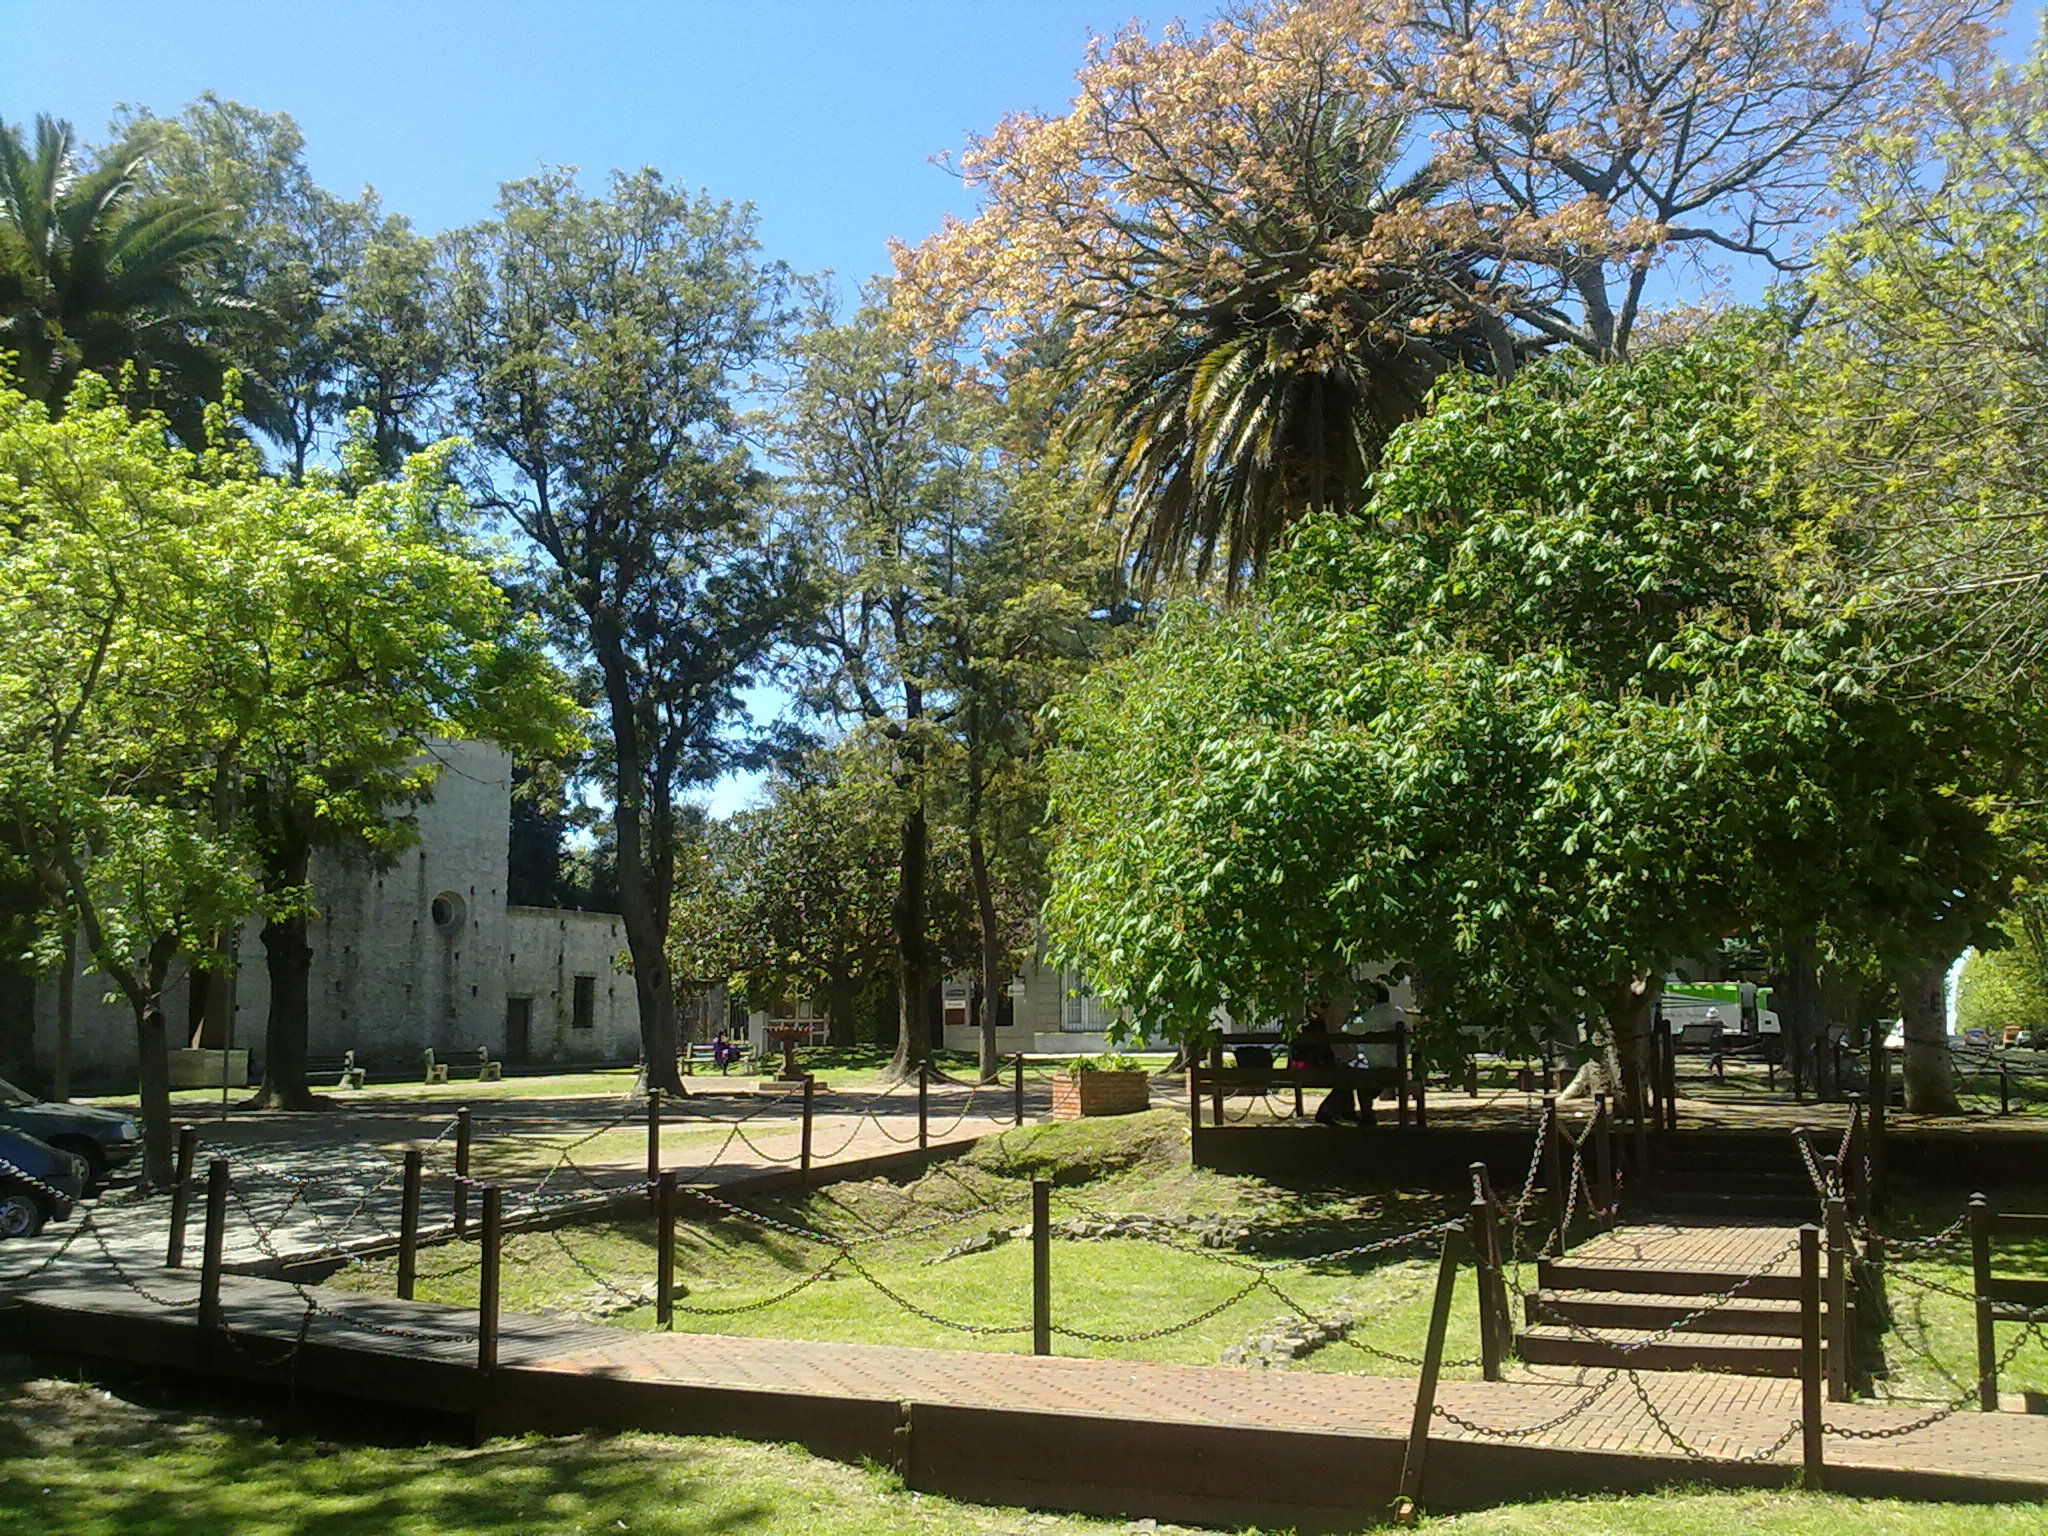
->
[[0, 381, 258, 1180]]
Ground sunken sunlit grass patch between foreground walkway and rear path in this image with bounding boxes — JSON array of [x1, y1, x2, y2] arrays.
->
[[332, 1110, 1477, 1376]]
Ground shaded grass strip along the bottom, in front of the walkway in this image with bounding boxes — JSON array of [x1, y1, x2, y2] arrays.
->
[[0, 1358, 2048, 1536]]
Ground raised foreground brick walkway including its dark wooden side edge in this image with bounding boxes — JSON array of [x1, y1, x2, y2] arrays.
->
[[14, 1261, 2048, 1530]]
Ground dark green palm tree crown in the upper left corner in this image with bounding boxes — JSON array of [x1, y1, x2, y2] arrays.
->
[[0, 117, 260, 442]]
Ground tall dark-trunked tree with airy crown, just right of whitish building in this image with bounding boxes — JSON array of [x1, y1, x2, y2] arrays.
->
[[440, 170, 793, 1094]]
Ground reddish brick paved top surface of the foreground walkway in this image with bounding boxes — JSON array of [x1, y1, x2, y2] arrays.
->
[[16, 1272, 2048, 1499]]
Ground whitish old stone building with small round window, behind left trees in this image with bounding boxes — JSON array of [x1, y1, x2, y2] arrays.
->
[[35, 741, 639, 1083]]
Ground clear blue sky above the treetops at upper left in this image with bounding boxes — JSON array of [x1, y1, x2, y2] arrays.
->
[[0, 0, 2038, 813]]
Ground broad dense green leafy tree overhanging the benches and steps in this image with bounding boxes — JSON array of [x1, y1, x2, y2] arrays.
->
[[1049, 338, 2021, 1122]]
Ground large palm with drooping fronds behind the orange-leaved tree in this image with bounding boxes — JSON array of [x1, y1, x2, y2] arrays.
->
[[1061, 113, 1516, 588]]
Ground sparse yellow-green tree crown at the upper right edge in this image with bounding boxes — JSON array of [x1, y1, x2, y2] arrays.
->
[[1782, 31, 2048, 684]]
